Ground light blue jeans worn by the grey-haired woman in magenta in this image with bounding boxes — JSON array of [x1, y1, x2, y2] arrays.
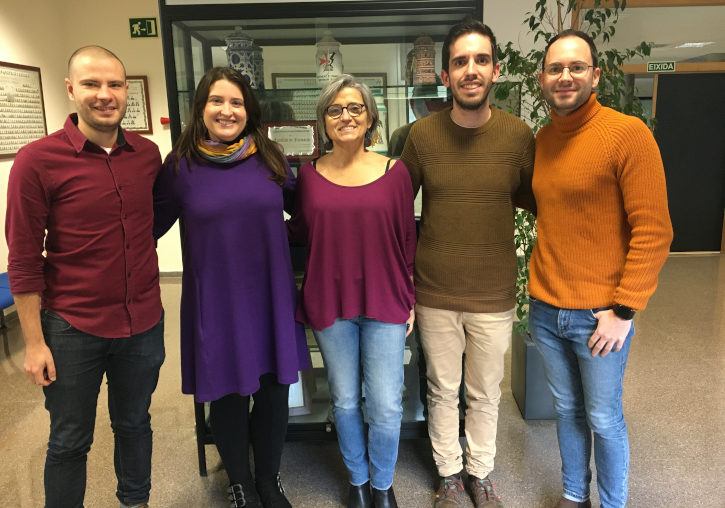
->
[[314, 316, 405, 490]]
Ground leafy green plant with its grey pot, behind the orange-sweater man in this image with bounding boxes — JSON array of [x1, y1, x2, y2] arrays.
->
[[494, 0, 653, 419]]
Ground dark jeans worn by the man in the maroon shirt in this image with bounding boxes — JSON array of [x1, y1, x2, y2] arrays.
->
[[41, 310, 165, 508]]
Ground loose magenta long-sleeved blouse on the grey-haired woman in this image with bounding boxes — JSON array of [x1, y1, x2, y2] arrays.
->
[[288, 161, 416, 330]]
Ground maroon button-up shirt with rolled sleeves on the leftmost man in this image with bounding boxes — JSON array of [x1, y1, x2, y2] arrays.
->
[[5, 114, 161, 337]]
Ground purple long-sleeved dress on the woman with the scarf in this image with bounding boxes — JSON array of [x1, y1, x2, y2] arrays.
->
[[154, 154, 310, 402]]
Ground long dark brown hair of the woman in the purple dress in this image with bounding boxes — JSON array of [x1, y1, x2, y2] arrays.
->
[[172, 67, 287, 185]]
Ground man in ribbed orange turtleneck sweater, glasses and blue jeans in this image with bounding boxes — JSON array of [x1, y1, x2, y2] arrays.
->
[[529, 30, 672, 508]]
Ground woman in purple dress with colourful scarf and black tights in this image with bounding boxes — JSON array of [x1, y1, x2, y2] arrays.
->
[[154, 67, 309, 508]]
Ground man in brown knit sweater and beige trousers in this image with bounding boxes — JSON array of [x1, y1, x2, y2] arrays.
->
[[401, 17, 535, 507]]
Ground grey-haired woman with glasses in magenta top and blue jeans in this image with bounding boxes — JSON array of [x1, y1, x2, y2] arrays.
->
[[290, 75, 416, 508]]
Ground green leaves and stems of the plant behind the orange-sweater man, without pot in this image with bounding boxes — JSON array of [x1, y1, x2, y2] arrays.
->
[[494, 0, 653, 332]]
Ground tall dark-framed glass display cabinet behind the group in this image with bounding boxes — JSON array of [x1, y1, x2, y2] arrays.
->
[[159, 0, 483, 468]]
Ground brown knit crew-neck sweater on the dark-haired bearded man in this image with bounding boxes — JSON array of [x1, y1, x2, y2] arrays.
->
[[401, 108, 535, 312]]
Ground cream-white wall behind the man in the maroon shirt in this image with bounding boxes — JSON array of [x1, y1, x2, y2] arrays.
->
[[0, 0, 181, 271]]
